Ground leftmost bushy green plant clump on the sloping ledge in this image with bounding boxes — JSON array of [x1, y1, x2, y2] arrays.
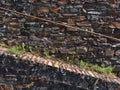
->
[[9, 45, 26, 54]]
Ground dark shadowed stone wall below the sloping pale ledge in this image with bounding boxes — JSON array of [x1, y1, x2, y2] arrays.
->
[[0, 53, 119, 90]]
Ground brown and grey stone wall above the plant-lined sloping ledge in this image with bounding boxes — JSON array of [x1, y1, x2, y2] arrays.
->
[[0, 0, 120, 71]]
